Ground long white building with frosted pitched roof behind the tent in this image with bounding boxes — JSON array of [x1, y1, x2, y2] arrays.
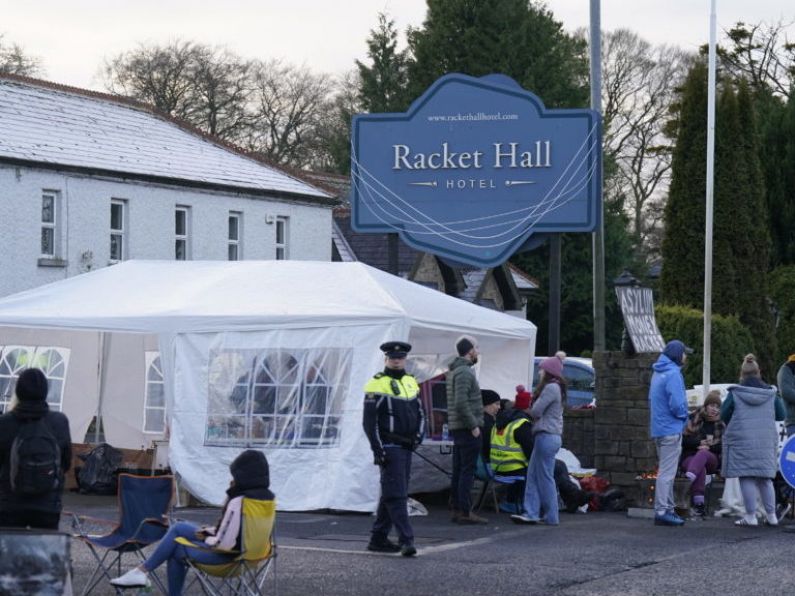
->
[[0, 75, 333, 298]]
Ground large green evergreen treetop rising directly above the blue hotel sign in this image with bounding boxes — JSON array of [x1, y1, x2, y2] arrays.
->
[[408, 0, 588, 107]]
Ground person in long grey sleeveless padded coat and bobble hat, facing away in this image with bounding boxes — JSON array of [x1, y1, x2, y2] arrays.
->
[[720, 354, 785, 526]]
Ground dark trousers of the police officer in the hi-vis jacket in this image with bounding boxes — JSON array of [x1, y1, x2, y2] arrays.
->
[[372, 446, 414, 544]]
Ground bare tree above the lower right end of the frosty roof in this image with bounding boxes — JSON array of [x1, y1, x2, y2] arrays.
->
[[247, 60, 334, 167]]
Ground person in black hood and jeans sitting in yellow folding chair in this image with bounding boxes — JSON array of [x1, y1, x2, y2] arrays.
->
[[110, 449, 274, 596]]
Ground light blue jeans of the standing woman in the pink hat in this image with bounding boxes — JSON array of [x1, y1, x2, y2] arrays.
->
[[524, 432, 562, 526]]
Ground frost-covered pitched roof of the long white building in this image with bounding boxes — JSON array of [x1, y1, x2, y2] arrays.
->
[[0, 75, 336, 205]]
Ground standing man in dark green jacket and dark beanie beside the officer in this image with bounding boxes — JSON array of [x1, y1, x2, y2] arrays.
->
[[445, 336, 488, 524]]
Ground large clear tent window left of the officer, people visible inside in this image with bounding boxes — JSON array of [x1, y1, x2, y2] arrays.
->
[[205, 348, 351, 448]]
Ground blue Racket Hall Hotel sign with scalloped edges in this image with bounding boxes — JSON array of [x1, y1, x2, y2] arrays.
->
[[351, 74, 601, 267]]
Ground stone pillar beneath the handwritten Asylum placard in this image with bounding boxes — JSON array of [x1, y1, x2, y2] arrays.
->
[[593, 352, 659, 503]]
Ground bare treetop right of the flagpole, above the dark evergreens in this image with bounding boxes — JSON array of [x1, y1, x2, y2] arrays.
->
[[719, 21, 795, 97]]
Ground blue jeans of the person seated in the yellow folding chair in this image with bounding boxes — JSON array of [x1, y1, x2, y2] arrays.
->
[[143, 522, 234, 596]]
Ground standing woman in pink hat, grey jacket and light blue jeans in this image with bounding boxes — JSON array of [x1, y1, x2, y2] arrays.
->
[[511, 356, 566, 526]]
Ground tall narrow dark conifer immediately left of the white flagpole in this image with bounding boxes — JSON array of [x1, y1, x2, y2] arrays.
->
[[660, 61, 707, 308]]
